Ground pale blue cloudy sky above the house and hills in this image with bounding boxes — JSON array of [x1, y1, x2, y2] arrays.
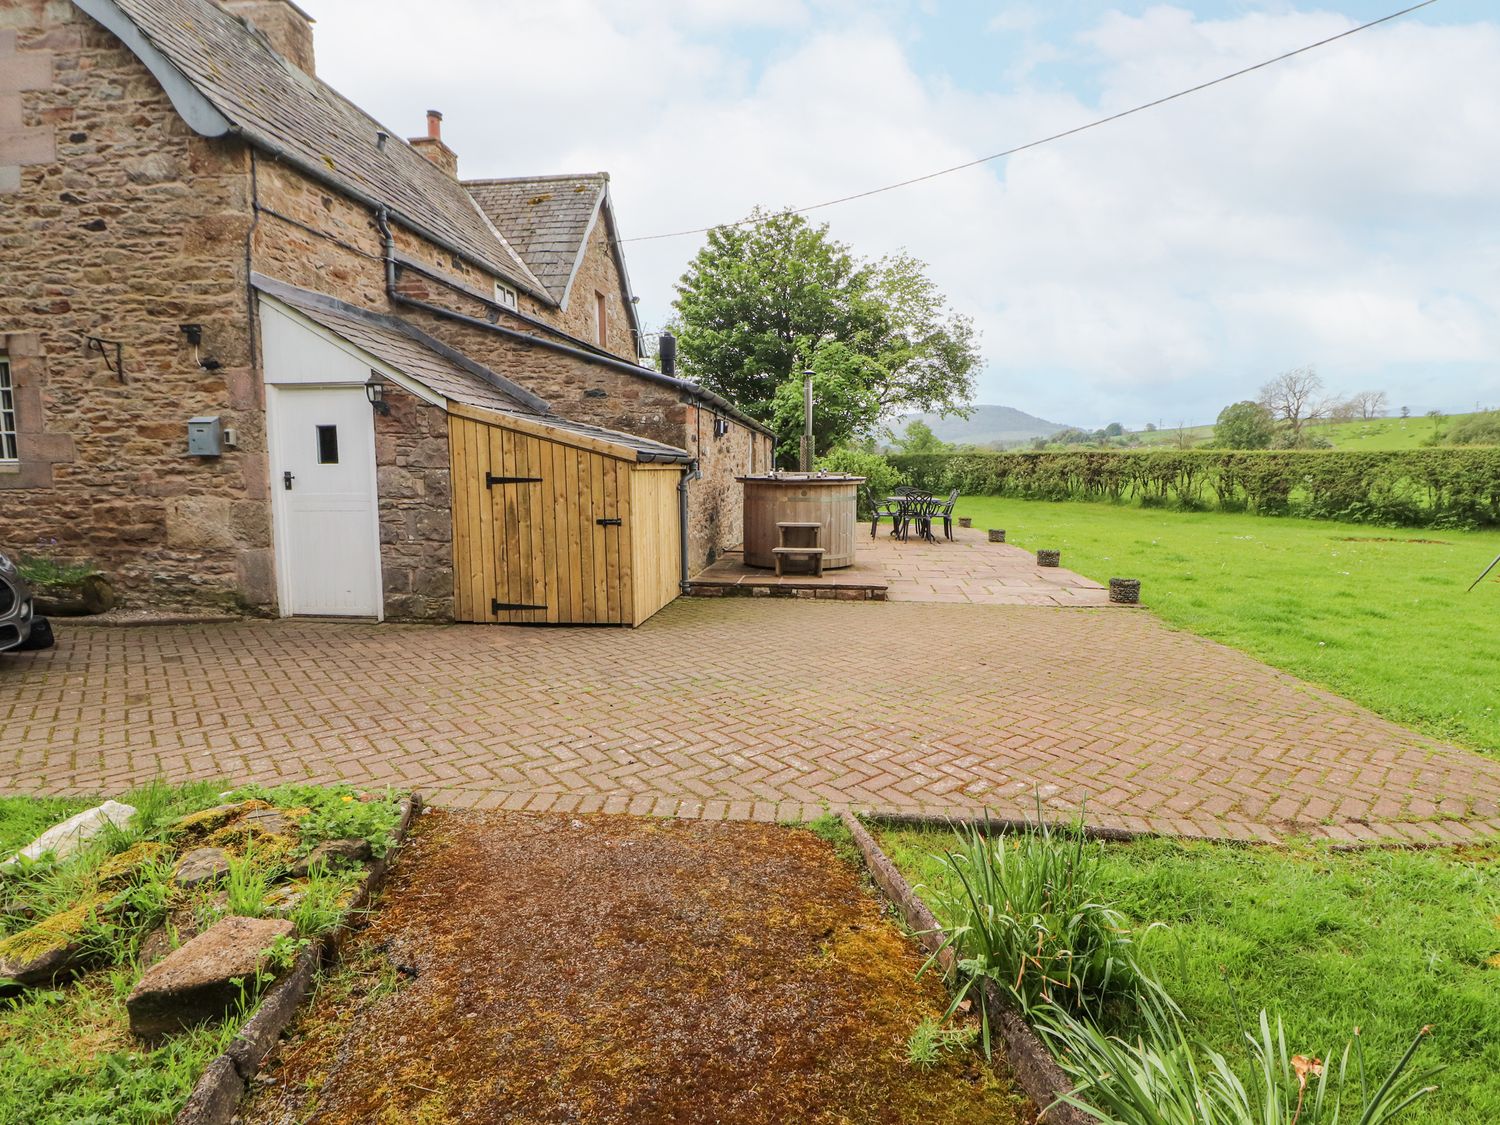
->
[[310, 0, 1500, 426]]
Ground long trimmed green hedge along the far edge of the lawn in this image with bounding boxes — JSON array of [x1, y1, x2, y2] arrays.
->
[[891, 449, 1500, 527]]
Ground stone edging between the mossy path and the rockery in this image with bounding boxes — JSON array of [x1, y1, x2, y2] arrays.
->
[[176, 792, 422, 1125]]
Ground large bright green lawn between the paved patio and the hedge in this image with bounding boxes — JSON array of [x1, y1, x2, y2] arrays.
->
[[957, 497, 1500, 753]]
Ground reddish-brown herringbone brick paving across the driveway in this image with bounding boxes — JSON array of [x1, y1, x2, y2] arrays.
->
[[0, 600, 1500, 840]]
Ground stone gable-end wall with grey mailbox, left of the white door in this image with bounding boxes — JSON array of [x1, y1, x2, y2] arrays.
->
[[0, 0, 264, 618]]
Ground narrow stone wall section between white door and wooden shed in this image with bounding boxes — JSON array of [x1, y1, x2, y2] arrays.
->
[[375, 383, 453, 621]]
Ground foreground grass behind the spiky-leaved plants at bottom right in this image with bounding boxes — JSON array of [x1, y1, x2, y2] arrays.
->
[[879, 831, 1500, 1125]]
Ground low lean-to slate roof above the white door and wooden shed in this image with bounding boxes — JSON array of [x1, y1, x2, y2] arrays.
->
[[251, 273, 690, 462]]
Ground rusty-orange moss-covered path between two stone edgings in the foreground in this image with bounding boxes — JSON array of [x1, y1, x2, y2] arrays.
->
[[243, 812, 1029, 1125]]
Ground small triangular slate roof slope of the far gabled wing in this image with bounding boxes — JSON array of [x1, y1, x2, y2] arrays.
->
[[464, 173, 609, 302]]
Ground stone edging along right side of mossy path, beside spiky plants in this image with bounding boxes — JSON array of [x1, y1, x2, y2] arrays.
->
[[840, 813, 1094, 1125]]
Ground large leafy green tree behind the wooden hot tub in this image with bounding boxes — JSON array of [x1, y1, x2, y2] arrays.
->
[[675, 210, 980, 453]]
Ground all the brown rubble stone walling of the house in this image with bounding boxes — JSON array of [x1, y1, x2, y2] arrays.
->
[[0, 0, 764, 620]]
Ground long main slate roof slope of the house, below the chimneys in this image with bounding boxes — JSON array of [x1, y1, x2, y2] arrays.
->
[[105, 0, 551, 300]]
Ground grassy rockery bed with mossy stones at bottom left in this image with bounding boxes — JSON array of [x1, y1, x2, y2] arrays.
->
[[0, 783, 411, 1125]]
